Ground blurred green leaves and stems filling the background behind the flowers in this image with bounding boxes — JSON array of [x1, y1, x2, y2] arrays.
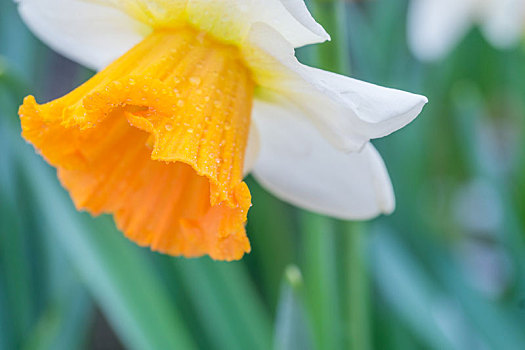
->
[[0, 0, 525, 350]]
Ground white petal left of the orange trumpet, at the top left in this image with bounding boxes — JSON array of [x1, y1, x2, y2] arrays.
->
[[18, 0, 149, 69]]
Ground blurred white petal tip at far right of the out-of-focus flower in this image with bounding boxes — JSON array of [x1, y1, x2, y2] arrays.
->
[[482, 0, 525, 48]]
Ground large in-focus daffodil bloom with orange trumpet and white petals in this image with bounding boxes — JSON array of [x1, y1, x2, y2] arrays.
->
[[19, 0, 426, 260]]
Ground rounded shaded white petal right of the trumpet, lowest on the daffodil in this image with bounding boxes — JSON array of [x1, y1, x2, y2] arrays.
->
[[253, 101, 394, 219]]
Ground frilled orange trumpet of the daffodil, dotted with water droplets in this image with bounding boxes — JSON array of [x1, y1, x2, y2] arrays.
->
[[19, 27, 254, 260]]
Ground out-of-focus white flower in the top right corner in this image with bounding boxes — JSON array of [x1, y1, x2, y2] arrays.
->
[[407, 0, 525, 61]]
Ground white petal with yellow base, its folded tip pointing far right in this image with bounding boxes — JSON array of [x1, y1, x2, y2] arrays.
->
[[244, 26, 427, 151]]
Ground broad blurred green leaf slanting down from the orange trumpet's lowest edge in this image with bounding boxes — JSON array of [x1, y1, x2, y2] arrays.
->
[[174, 258, 272, 350]]
